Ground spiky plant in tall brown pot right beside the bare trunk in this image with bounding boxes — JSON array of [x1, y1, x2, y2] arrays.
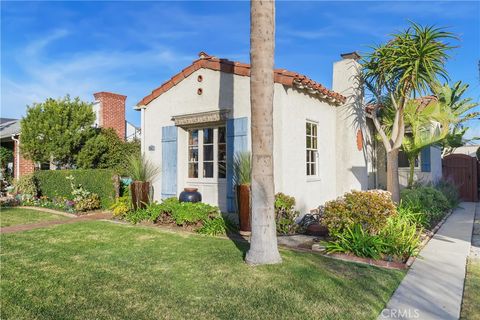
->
[[233, 152, 252, 235]]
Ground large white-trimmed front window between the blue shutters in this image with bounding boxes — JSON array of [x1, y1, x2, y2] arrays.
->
[[188, 126, 227, 179]]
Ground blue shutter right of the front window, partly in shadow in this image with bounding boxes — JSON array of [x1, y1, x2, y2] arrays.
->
[[227, 117, 248, 212]]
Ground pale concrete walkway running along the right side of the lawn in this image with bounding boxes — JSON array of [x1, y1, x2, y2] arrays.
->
[[378, 202, 480, 320]]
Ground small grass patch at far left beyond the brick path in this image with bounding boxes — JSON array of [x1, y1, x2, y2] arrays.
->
[[0, 208, 69, 227]]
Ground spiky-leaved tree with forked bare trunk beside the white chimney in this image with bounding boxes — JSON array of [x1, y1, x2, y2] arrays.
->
[[363, 23, 455, 202]]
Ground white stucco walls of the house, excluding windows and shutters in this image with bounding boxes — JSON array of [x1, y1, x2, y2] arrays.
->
[[142, 61, 368, 214]]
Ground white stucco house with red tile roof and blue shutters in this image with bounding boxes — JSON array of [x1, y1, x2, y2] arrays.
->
[[136, 52, 441, 213]]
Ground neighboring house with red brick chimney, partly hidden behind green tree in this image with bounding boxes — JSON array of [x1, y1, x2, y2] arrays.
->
[[0, 92, 141, 178]]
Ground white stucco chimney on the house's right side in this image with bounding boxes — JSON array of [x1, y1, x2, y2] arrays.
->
[[332, 52, 368, 195]]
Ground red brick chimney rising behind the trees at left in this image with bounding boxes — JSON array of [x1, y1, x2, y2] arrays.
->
[[93, 91, 127, 140]]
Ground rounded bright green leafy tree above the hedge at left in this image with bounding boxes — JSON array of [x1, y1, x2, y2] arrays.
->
[[20, 95, 95, 167]]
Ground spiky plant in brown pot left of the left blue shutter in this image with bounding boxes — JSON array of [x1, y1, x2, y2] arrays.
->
[[128, 155, 160, 210]]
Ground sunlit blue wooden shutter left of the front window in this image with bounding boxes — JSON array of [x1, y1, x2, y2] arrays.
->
[[162, 126, 177, 199]]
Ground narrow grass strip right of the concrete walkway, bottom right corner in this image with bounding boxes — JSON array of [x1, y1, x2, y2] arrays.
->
[[460, 259, 480, 320]]
